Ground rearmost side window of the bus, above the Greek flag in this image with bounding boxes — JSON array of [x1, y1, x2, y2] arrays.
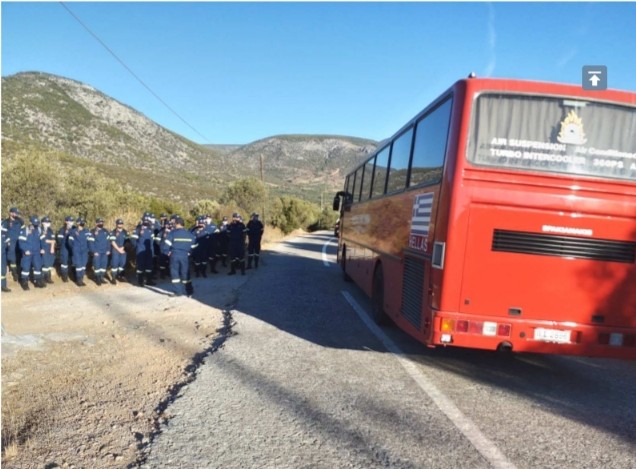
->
[[409, 99, 453, 187]]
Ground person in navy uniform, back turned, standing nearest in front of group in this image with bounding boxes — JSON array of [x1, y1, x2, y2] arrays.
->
[[165, 217, 197, 296]]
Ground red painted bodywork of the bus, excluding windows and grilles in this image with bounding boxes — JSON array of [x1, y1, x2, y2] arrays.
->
[[339, 79, 636, 359]]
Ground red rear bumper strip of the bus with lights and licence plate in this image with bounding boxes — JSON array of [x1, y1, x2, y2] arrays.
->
[[430, 312, 636, 360]]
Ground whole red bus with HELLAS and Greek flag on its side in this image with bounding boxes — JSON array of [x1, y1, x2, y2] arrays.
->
[[334, 78, 636, 359]]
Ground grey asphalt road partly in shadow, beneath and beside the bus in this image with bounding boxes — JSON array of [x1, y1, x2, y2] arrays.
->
[[144, 232, 636, 469]]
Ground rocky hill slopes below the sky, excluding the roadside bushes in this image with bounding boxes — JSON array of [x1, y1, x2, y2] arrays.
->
[[2, 72, 376, 202]]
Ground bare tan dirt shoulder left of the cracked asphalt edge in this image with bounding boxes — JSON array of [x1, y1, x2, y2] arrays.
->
[[2, 266, 235, 468]]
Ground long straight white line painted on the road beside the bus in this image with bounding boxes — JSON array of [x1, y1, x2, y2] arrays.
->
[[341, 290, 515, 469]]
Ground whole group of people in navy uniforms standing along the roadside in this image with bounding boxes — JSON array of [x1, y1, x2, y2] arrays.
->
[[2, 207, 264, 296]]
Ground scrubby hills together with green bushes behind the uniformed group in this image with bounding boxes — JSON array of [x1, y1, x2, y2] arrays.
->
[[2, 72, 375, 232]]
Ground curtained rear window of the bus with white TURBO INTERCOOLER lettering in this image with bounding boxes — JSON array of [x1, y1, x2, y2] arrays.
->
[[468, 94, 636, 181]]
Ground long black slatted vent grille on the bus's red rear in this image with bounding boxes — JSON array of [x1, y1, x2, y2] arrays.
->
[[492, 230, 636, 264]]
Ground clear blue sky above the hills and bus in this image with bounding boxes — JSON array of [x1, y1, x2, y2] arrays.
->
[[1, 1, 636, 144]]
